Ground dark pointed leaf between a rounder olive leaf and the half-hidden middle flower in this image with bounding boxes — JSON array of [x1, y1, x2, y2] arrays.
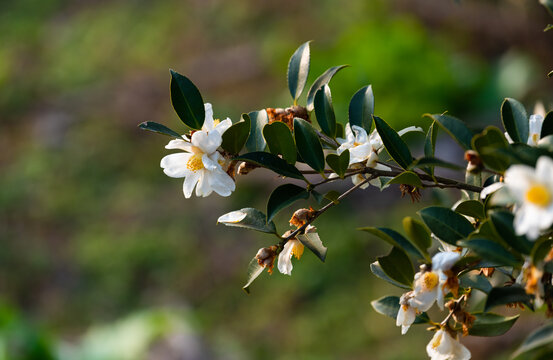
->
[[294, 118, 325, 173]]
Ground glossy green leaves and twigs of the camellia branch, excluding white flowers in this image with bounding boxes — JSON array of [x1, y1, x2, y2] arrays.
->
[[140, 14, 553, 355]]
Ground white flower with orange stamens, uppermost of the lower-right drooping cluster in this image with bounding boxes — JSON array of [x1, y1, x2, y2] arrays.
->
[[409, 251, 461, 311]]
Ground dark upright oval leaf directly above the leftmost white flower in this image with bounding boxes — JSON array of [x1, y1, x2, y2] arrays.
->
[[170, 70, 205, 130]]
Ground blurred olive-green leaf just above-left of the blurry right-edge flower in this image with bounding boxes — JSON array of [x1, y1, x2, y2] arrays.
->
[[472, 126, 511, 172]]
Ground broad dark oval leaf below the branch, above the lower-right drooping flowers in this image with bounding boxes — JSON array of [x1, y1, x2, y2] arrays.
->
[[419, 206, 474, 245]]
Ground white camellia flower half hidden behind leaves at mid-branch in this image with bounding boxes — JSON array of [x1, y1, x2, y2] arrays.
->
[[336, 123, 422, 189]]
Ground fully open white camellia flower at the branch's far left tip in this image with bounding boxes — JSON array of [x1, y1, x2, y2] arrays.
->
[[160, 103, 236, 199]]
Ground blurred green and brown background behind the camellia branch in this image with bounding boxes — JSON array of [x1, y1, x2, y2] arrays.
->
[[0, 0, 553, 360]]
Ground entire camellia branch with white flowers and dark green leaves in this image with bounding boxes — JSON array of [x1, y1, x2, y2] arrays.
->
[[139, 0, 553, 359]]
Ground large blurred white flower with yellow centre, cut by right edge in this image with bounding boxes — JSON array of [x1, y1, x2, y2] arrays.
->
[[505, 156, 553, 240]]
